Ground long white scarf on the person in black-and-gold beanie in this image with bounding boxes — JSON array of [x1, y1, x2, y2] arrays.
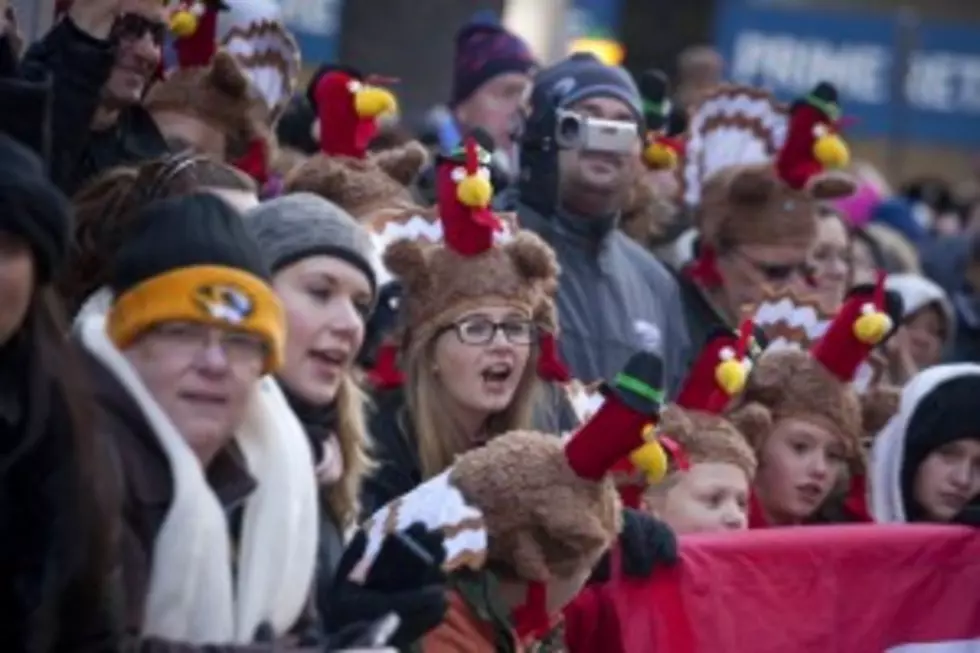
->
[[75, 312, 319, 645]]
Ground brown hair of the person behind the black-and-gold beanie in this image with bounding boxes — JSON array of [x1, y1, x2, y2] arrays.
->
[[57, 153, 256, 314]]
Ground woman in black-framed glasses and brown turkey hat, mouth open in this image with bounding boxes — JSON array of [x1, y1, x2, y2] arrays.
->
[[363, 201, 557, 512]]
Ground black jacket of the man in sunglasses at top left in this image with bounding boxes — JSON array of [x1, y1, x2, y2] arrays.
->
[[20, 18, 168, 194]]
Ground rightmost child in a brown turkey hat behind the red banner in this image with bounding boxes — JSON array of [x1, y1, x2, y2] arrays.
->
[[727, 277, 897, 528]]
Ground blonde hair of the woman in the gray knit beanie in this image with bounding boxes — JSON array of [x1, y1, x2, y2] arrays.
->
[[324, 374, 374, 528]]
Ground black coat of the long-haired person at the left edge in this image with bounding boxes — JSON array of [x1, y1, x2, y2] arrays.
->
[[0, 334, 122, 653]]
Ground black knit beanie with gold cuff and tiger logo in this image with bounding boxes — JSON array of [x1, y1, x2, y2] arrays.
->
[[106, 193, 286, 372]]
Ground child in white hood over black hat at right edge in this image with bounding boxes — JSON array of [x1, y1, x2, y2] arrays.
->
[[869, 363, 980, 526]]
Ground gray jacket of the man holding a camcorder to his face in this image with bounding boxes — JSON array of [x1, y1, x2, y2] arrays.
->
[[517, 203, 690, 393]]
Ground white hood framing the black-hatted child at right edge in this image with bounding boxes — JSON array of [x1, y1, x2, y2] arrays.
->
[[868, 363, 980, 523]]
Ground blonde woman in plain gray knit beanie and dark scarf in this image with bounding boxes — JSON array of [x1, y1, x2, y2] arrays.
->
[[244, 193, 377, 576]]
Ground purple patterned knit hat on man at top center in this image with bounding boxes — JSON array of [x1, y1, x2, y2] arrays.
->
[[449, 22, 537, 107]]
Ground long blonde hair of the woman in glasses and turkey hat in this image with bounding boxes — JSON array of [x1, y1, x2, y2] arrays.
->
[[403, 338, 538, 480]]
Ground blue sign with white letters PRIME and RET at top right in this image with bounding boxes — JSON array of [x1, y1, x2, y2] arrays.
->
[[717, 0, 980, 147]]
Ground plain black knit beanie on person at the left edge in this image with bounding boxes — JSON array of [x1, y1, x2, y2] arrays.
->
[[0, 134, 72, 283]]
